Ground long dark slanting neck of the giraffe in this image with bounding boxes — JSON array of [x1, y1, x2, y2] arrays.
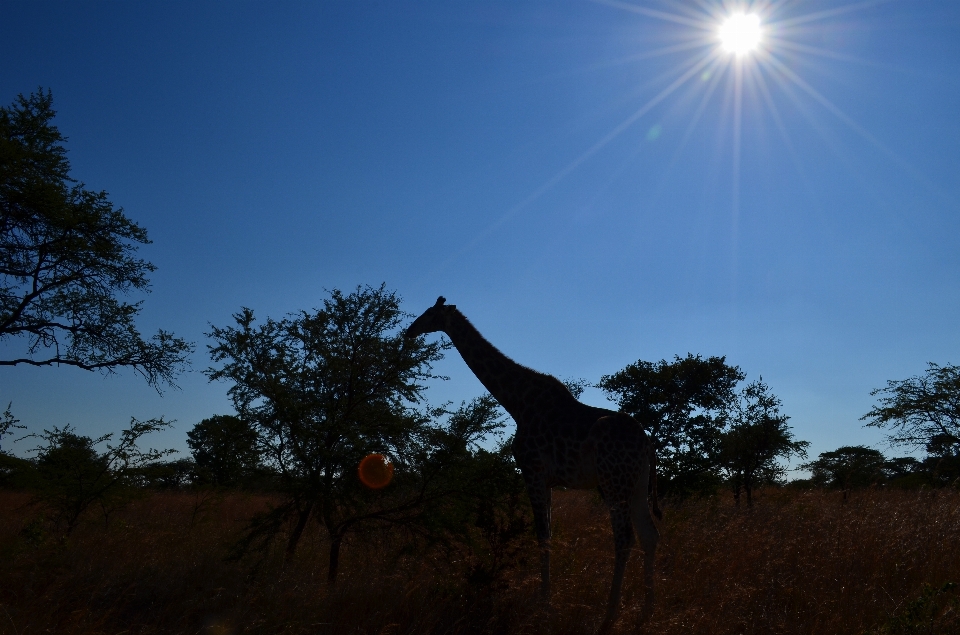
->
[[445, 310, 539, 414]]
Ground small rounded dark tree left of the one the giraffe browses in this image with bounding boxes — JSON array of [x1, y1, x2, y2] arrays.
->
[[187, 415, 260, 485]]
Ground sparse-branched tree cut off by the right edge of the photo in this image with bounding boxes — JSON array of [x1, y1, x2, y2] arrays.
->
[[860, 362, 960, 457]]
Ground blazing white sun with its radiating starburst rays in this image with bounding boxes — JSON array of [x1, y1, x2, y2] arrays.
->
[[458, 0, 899, 260]]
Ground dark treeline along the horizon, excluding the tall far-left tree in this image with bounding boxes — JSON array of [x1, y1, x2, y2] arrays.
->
[[0, 285, 960, 552]]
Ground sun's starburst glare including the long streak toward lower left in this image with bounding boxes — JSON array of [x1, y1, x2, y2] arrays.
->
[[440, 0, 916, 278]]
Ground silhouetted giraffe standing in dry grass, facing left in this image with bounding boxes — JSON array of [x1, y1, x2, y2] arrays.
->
[[406, 296, 663, 633]]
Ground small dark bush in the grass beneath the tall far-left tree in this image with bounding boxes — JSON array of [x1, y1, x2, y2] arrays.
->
[[29, 419, 175, 536]]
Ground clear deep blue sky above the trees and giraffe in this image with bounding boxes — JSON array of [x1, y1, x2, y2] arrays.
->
[[0, 0, 960, 468]]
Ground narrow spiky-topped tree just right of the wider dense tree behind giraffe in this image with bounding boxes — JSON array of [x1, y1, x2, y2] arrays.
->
[[721, 378, 810, 506]]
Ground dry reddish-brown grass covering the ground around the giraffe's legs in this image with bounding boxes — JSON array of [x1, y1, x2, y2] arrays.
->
[[0, 490, 960, 635]]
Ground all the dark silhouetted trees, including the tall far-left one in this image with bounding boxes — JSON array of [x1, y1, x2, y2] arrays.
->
[[0, 90, 960, 560]]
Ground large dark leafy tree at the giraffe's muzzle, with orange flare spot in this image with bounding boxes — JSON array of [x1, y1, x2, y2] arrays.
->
[[207, 286, 515, 582]]
